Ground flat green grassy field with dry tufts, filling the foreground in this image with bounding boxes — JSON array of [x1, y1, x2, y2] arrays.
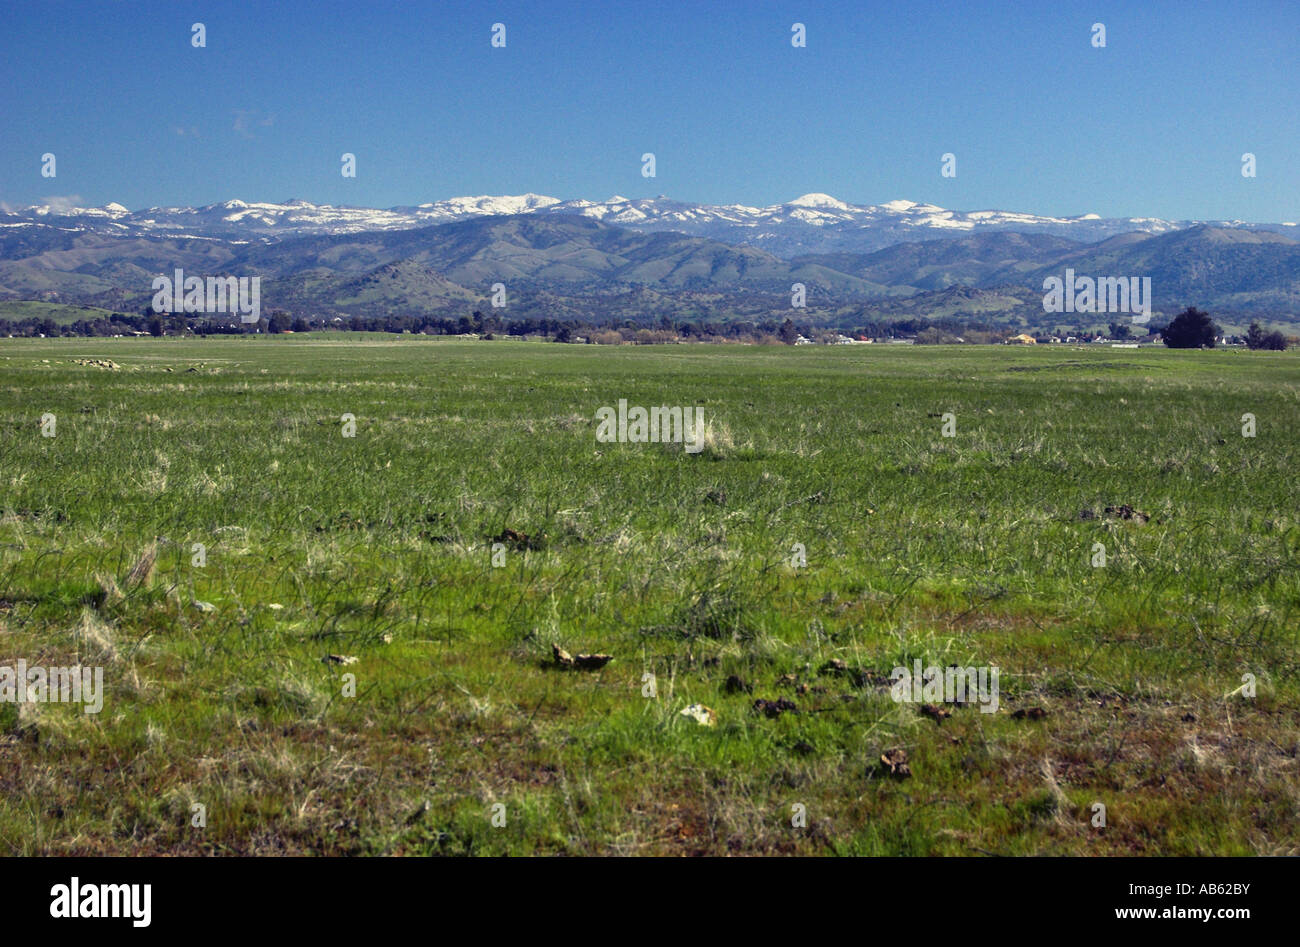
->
[[0, 336, 1300, 855]]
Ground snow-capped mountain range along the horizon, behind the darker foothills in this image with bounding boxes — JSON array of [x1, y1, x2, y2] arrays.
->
[[0, 193, 1296, 256]]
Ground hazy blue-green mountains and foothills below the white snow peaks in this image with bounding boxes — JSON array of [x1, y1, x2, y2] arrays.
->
[[0, 195, 1300, 325]]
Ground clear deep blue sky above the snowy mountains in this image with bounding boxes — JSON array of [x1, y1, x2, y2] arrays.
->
[[0, 0, 1300, 221]]
